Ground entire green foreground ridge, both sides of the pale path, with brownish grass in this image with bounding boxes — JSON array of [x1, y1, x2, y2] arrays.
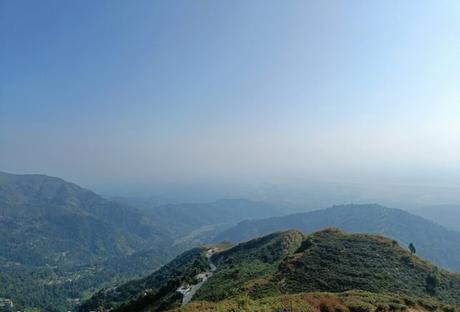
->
[[87, 229, 460, 312]]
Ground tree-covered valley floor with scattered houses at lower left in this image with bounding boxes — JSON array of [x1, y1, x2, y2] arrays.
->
[[0, 246, 178, 311]]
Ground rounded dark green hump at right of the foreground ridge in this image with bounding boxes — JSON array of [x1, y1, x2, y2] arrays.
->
[[274, 229, 460, 305]]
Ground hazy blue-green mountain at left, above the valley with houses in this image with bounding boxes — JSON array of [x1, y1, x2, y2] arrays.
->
[[0, 173, 171, 265]]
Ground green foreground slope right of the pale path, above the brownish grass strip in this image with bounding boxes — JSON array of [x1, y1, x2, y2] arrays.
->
[[196, 229, 460, 304]]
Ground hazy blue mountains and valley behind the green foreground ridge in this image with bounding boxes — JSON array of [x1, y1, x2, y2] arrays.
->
[[0, 172, 460, 311]]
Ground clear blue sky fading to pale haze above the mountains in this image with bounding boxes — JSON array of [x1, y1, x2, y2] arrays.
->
[[0, 0, 460, 199]]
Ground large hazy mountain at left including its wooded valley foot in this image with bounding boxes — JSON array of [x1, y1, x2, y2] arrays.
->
[[0, 172, 177, 311]]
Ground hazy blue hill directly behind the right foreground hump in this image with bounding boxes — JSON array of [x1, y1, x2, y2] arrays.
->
[[216, 205, 460, 271]]
